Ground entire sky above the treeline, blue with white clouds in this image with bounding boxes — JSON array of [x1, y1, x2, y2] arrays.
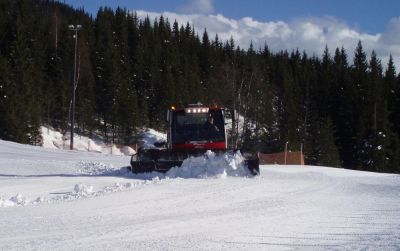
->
[[60, 0, 400, 69]]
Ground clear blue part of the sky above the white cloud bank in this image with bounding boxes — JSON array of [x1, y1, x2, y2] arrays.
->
[[65, 0, 400, 33]]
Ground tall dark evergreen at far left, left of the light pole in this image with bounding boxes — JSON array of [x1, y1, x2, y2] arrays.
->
[[6, 1, 41, 145]]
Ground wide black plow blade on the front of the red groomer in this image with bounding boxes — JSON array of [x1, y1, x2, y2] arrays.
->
[[129, 149, 260, 175]]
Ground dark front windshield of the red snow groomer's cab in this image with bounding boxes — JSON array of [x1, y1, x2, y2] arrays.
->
[[172, 110, 225, 144]]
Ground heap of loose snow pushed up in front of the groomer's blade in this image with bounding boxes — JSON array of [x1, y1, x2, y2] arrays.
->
[[165, 151, 251, 178]]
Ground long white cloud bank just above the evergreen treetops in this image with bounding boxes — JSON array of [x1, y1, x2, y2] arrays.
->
[[137, 11, 400, 70]]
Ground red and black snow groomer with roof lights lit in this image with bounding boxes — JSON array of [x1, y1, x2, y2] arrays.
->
[[130, 104, 260, 175]]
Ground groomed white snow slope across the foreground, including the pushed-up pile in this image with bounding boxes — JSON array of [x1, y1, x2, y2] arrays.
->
[[0, 141, 400, 250]]
